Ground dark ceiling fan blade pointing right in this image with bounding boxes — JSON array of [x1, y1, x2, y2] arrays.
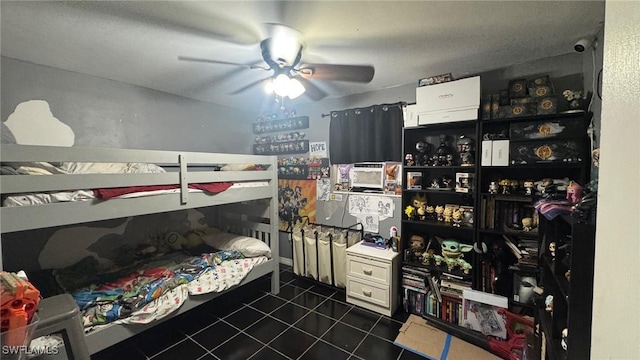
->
[[297, 64, 375, 83]]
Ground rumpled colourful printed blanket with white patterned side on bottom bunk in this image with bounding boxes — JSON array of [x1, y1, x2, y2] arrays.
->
[[72, 251, 268, 328]]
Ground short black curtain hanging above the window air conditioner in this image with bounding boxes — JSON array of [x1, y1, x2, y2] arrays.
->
[[329, 103, 404, 164]]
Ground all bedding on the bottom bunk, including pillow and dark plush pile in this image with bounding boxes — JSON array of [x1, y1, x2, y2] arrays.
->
[[43, 228, 271, 330]]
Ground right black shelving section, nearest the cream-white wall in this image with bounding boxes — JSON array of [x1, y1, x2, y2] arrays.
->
[[477, 113, 595, 360]]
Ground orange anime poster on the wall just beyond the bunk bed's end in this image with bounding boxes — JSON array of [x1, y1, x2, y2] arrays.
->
[[278, 179, 317, 232]]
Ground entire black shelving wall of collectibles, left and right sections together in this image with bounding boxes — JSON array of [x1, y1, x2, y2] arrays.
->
[[401, 113, 595, 360]]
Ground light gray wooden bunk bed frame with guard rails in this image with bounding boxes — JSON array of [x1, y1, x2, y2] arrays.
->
[[0, 144, 279, 354]]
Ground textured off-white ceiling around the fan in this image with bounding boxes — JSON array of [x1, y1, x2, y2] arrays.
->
[[0, 1, 604, 108]]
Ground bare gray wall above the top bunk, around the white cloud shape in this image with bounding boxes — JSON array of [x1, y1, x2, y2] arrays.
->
[[1, 57, 254, 153]]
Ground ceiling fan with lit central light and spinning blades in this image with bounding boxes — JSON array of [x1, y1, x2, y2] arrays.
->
[[178, 24, 375, 101]]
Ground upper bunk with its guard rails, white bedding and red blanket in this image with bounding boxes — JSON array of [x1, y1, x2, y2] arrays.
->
[[0, 145, 277, 232]]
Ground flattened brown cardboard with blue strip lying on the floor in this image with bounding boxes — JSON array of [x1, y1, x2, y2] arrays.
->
[[395, 315, 500, 360]]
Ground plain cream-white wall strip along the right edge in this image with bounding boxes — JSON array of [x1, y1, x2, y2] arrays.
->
[[592, 1, 640, 359]]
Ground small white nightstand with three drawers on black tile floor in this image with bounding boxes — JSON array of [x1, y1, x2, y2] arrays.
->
[[346, 242, 400, 316]]
